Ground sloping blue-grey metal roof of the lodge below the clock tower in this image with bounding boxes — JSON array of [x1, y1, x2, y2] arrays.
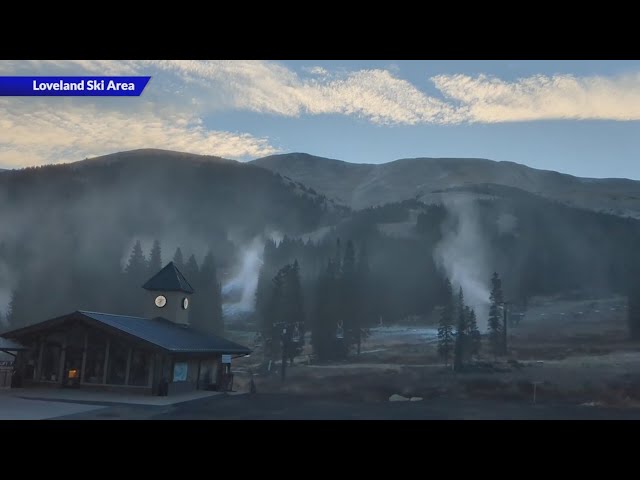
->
[[78, 310, 251, 355]]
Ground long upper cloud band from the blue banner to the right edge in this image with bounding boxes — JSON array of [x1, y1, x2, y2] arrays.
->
[[132, 61, 640, 125]]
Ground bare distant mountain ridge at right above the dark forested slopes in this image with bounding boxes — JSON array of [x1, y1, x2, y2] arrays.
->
[[252, 153, 640, 218]]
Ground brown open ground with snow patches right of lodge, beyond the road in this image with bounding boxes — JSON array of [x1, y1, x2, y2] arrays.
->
[[230, 297, 640, 409]]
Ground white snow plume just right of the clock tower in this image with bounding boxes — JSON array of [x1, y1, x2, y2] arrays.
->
[[222, 235, 265, 316]]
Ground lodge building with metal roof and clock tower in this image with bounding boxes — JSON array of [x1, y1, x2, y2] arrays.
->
[[2, 262, 250, 395]]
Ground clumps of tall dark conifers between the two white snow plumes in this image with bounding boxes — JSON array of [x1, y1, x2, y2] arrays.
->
[[256, 239, 375, 363]]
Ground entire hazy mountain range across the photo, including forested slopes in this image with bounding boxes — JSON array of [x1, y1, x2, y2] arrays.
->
[[0, 150, 640, 330]]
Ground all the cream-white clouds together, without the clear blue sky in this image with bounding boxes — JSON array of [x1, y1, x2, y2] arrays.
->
[[0, 60, 640, 166]]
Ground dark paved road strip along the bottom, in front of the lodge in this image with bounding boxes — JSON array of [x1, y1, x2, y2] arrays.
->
[[53, 394, 640, 420]]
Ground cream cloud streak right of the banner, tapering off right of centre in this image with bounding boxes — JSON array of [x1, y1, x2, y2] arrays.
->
[[141, 60, 460, 125]]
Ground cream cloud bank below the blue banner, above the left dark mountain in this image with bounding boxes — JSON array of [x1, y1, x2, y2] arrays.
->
[[0, 99, 277, 168]]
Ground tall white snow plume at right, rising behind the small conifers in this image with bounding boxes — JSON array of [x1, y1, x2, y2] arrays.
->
[[433, 197, 491, 331]]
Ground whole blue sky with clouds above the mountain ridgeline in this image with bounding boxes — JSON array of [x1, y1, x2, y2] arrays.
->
[[0, 60, 640, 179]]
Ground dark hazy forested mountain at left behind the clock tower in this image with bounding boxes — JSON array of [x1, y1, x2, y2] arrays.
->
[[0, 150, 339, 273]]
